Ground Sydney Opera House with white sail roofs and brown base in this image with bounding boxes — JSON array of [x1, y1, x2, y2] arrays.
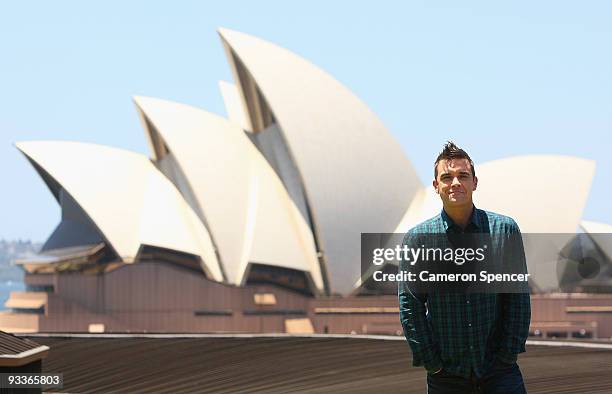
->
[[0, 29, 612, 338]]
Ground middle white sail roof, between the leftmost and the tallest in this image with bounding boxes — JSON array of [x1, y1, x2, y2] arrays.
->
[[134, 97, 323, 291]]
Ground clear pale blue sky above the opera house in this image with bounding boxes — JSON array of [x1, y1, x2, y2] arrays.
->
[[0, 0, 612, 241]]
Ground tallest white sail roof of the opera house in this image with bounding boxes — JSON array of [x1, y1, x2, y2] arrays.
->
[[219, 29, 420, 293]]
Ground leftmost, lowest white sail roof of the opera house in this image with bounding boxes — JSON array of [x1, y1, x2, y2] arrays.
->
[[16, 141, 223, 280]]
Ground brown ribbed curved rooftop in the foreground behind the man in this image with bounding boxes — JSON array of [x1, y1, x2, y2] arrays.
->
[[22, 335, 612, 394]]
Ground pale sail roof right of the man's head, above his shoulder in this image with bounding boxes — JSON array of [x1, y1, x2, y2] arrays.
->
[[474, 155, 595, 233]]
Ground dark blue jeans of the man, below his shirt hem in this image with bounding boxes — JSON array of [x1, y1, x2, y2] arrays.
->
[[427, 359, 527, 394]]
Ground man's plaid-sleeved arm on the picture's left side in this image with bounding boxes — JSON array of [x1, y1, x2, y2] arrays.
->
[[398, 234, 442, 373]]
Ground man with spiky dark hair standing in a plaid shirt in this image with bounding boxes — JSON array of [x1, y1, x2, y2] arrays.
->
[[399, 141, 531, 394]]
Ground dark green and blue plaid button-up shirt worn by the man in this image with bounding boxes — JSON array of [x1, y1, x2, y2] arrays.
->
[[399, 207, 531, 377]]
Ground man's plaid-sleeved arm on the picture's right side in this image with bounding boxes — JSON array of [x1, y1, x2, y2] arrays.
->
[[498, 223, 531, 363]]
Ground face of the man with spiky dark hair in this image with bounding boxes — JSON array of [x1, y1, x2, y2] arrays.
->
[[433, 159, 478, 208]]
